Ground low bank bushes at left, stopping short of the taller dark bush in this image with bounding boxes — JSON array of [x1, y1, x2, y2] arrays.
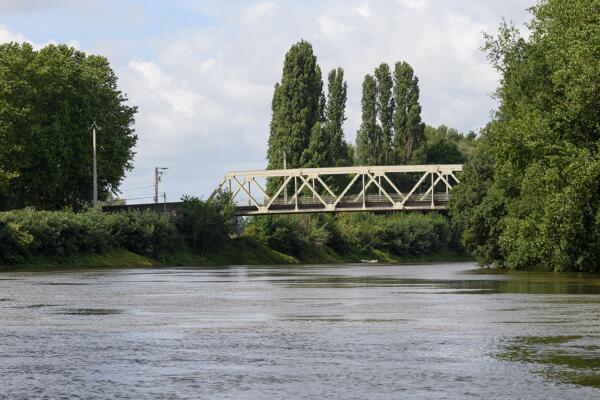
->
[[0, 209, 179, 264]]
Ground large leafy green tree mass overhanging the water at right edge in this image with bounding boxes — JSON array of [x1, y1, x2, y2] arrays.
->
[[452, 0, 600, 271]]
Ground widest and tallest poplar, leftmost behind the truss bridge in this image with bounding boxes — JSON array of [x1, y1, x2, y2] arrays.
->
[[267, 40, 325, 169]]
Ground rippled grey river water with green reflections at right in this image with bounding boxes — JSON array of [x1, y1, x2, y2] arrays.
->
[[0, 263, 600, 399]]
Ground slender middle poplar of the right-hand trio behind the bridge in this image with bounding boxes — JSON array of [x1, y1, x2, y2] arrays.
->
[[375, 63, 394, 165]]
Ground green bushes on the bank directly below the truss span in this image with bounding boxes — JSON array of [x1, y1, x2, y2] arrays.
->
[[245, 213, 460, 259]]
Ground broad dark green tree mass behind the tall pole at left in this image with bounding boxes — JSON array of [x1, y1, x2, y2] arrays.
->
[[0, 43, 137, 209]]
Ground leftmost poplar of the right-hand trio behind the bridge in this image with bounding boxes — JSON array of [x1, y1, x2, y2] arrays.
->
[[356, 74, 383, 165]]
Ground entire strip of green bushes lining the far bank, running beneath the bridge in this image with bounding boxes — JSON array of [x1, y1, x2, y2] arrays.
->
[[0, 194, 466, 269]]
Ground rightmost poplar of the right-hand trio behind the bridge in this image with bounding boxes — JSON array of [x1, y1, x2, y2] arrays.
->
[[394, 62, 425, 164]]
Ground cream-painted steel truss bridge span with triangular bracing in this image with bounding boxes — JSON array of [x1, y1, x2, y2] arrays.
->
[[211, 164, 462, 216]]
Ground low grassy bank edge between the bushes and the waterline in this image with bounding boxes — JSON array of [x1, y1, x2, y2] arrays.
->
[[0, 237, 471, 272]]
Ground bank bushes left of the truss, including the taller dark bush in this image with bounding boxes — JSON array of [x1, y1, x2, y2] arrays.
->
[[0, 195, 234, 265]]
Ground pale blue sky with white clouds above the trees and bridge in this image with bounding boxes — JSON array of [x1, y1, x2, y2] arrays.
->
[[0, 0, 532, 203]]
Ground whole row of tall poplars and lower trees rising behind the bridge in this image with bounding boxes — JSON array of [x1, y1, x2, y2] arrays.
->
[[267, 40, 475, 177]]
